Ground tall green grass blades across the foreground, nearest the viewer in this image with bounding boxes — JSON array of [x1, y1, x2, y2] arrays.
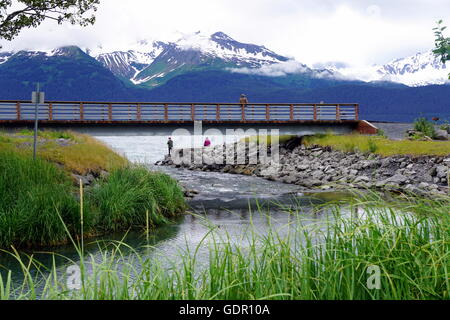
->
[[0, 192, 450, 300]]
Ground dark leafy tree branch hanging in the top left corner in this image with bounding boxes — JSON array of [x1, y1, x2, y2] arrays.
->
[[0, 0, 100, 40]]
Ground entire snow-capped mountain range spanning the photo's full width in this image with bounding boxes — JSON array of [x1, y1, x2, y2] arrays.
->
[[0, 32, 450, 87]]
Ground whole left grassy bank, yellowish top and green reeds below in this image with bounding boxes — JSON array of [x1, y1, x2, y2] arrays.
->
[[0, 132, 185, 247]]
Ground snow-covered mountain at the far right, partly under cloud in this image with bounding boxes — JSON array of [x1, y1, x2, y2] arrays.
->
[[326, 50, 450, 87]]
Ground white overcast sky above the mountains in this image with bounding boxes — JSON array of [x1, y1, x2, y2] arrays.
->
[[1, 0, 450, 66]]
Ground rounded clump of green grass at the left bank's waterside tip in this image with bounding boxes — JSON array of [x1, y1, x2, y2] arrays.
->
[[88, 167, 185, 231]]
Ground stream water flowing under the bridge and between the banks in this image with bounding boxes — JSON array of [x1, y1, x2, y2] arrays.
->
[[0, 136, 358, 296]]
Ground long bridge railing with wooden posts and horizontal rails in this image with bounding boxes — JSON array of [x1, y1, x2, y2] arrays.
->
[[0, 101, 359, 123]]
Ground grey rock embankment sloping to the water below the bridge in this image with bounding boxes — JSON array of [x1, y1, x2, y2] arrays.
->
[[156, 141, 450, 195]]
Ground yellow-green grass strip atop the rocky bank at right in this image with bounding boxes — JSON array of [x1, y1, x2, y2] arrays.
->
[[304, 134, 450, 156]]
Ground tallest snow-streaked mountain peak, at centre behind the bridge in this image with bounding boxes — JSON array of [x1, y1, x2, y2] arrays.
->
[[87, 32, 288, 86]]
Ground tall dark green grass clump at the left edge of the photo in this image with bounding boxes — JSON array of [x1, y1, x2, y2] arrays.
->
[[0, 150, 79, 247]]
